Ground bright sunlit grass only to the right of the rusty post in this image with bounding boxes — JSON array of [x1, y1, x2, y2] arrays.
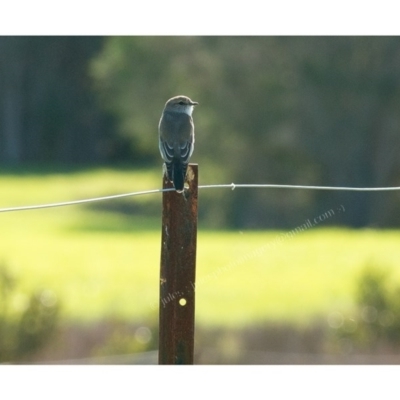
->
[[197, 229, 400, 324]]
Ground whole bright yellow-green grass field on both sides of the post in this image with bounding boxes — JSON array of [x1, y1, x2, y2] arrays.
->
[[0, 168, 400, 326]]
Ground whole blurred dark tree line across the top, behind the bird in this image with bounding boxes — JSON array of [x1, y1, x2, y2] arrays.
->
[[0, 37, 400, 228]]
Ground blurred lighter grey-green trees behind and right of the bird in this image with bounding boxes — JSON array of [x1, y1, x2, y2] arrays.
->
[[91, 37, 400, 228]]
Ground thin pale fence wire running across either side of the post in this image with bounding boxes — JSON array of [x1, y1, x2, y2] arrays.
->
[[0, 183, 400, 213]]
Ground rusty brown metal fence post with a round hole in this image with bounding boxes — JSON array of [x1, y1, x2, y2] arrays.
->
[[158, 164, 198, 364]]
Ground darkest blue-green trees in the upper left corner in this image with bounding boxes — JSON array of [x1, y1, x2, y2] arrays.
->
[[0, 37, 120, 164]]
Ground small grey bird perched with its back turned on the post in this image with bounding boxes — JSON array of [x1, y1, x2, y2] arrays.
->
[[158, 96, 199, 192]]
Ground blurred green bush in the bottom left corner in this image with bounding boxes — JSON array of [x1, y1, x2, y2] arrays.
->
[[0, 265, 59, 363]]
